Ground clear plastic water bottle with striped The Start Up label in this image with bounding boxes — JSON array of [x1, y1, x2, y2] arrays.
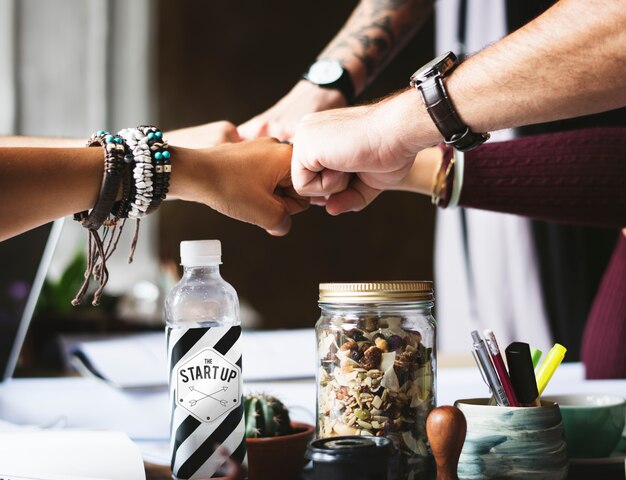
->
[[165, 240, 247, 479]]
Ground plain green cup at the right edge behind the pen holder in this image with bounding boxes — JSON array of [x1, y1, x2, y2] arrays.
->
[[544, 395, 626, 458]]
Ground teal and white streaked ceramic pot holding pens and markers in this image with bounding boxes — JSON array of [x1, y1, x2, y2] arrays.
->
[[454, 398, 569, 480]]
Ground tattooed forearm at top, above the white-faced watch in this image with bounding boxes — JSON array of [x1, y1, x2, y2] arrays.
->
[[319, 0, 434, 94]]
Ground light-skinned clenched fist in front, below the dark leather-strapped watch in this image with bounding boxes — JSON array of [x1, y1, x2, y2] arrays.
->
[[291, 91, 433, 215]]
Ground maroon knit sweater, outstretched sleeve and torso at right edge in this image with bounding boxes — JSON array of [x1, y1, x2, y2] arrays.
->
[[459, 128, 626, 378]]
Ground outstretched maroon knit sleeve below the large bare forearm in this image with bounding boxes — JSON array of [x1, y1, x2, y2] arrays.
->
[[459, 127, 626, 228]]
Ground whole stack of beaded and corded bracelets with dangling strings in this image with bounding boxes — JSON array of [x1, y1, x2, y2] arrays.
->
[[72, 126, 171, 305]]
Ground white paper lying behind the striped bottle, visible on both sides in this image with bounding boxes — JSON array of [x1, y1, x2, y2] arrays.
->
[[74, 328, 315, 388]]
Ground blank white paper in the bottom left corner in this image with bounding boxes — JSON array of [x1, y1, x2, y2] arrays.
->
[[0, 430, 146, 480]]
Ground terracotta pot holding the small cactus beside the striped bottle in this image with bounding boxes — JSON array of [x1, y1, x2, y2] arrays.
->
[[246, 422, 315, 480]]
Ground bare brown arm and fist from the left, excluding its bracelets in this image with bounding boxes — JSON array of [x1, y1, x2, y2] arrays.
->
[[0, 138, 308, 241]]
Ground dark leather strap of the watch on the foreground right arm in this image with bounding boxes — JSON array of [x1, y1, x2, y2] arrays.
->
[[417, 75, 489, 152]]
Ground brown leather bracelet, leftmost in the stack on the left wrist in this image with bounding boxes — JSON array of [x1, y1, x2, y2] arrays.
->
[[74, 131, 125, 230]]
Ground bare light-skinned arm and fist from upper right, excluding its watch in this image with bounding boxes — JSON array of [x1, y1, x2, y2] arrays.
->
[[292, 0, 626, 209]]
